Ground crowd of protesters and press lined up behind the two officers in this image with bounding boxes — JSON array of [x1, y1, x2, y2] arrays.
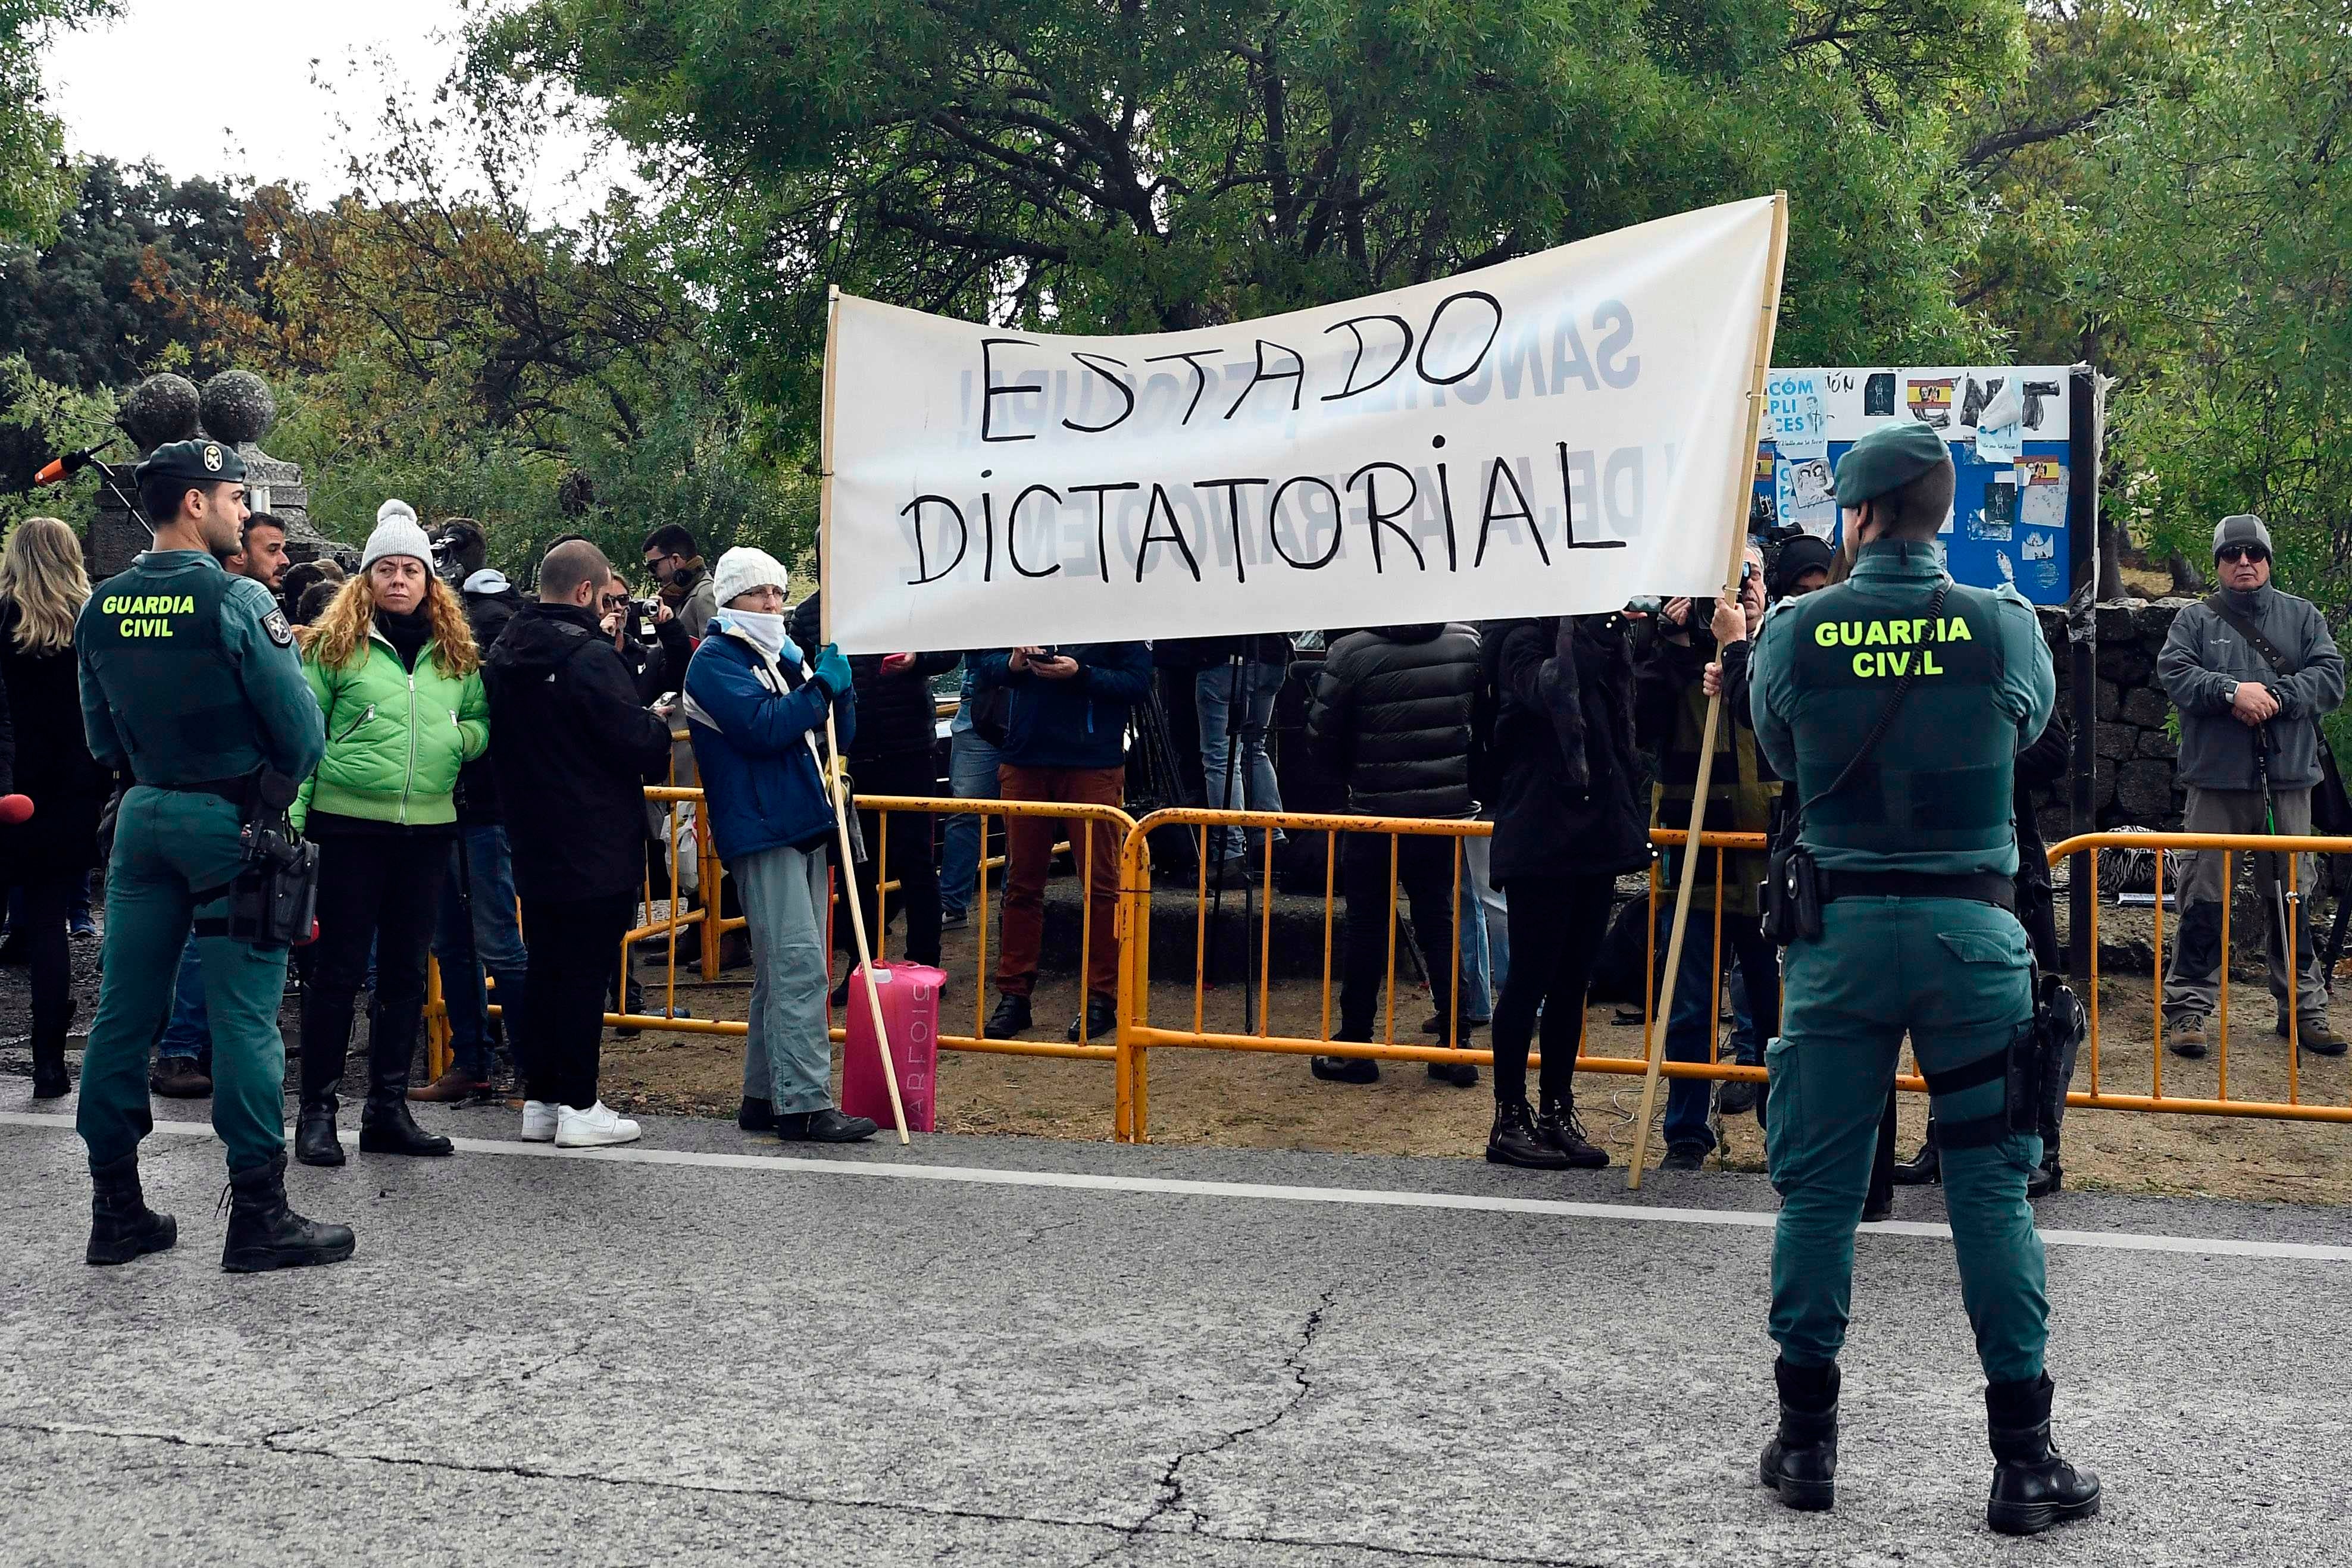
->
[[0, 434, 2342, 1279]]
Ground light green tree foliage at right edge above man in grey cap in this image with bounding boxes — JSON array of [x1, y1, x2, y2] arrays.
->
[[2086, 0, 2352, 616]]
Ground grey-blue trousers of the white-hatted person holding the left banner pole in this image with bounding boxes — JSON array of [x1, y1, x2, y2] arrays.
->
[[727, 844, 833, 1116]]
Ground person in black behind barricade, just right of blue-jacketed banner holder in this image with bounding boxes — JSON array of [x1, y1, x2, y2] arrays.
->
[[793, 588, 964, 982]]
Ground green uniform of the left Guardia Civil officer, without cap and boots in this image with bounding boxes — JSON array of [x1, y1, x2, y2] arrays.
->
[[73, 550, 324, 1170]]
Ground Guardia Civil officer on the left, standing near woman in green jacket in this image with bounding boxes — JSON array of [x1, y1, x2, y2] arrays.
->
[[73, 440, 351, 1274]]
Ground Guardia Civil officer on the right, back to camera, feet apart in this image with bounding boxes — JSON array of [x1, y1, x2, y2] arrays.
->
[[1752, 421, 2098, 1535]]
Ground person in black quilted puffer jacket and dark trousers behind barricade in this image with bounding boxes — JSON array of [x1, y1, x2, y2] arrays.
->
[[1308, 623, 1480, 1088]]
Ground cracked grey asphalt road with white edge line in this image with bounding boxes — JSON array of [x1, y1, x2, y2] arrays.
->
[[0, 1076, 2352, 1568]]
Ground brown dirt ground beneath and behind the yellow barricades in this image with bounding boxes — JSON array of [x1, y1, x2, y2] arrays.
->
[[605, 912, 2352, 1204]]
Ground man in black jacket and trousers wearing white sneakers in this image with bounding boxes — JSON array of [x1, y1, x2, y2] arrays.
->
[[482, 541, 670, 1147]]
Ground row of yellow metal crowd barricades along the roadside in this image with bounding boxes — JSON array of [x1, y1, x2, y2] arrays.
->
[[426, 785, 2352, 1143]]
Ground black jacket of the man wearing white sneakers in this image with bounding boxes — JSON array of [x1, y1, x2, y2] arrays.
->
[[482, 604, 670, 903]]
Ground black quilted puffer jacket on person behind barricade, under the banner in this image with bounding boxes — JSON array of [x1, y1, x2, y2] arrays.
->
[[1308, 623, 1480, 816]]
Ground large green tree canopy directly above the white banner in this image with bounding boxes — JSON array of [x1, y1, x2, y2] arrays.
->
[[475, 0, 2021, 423]]
